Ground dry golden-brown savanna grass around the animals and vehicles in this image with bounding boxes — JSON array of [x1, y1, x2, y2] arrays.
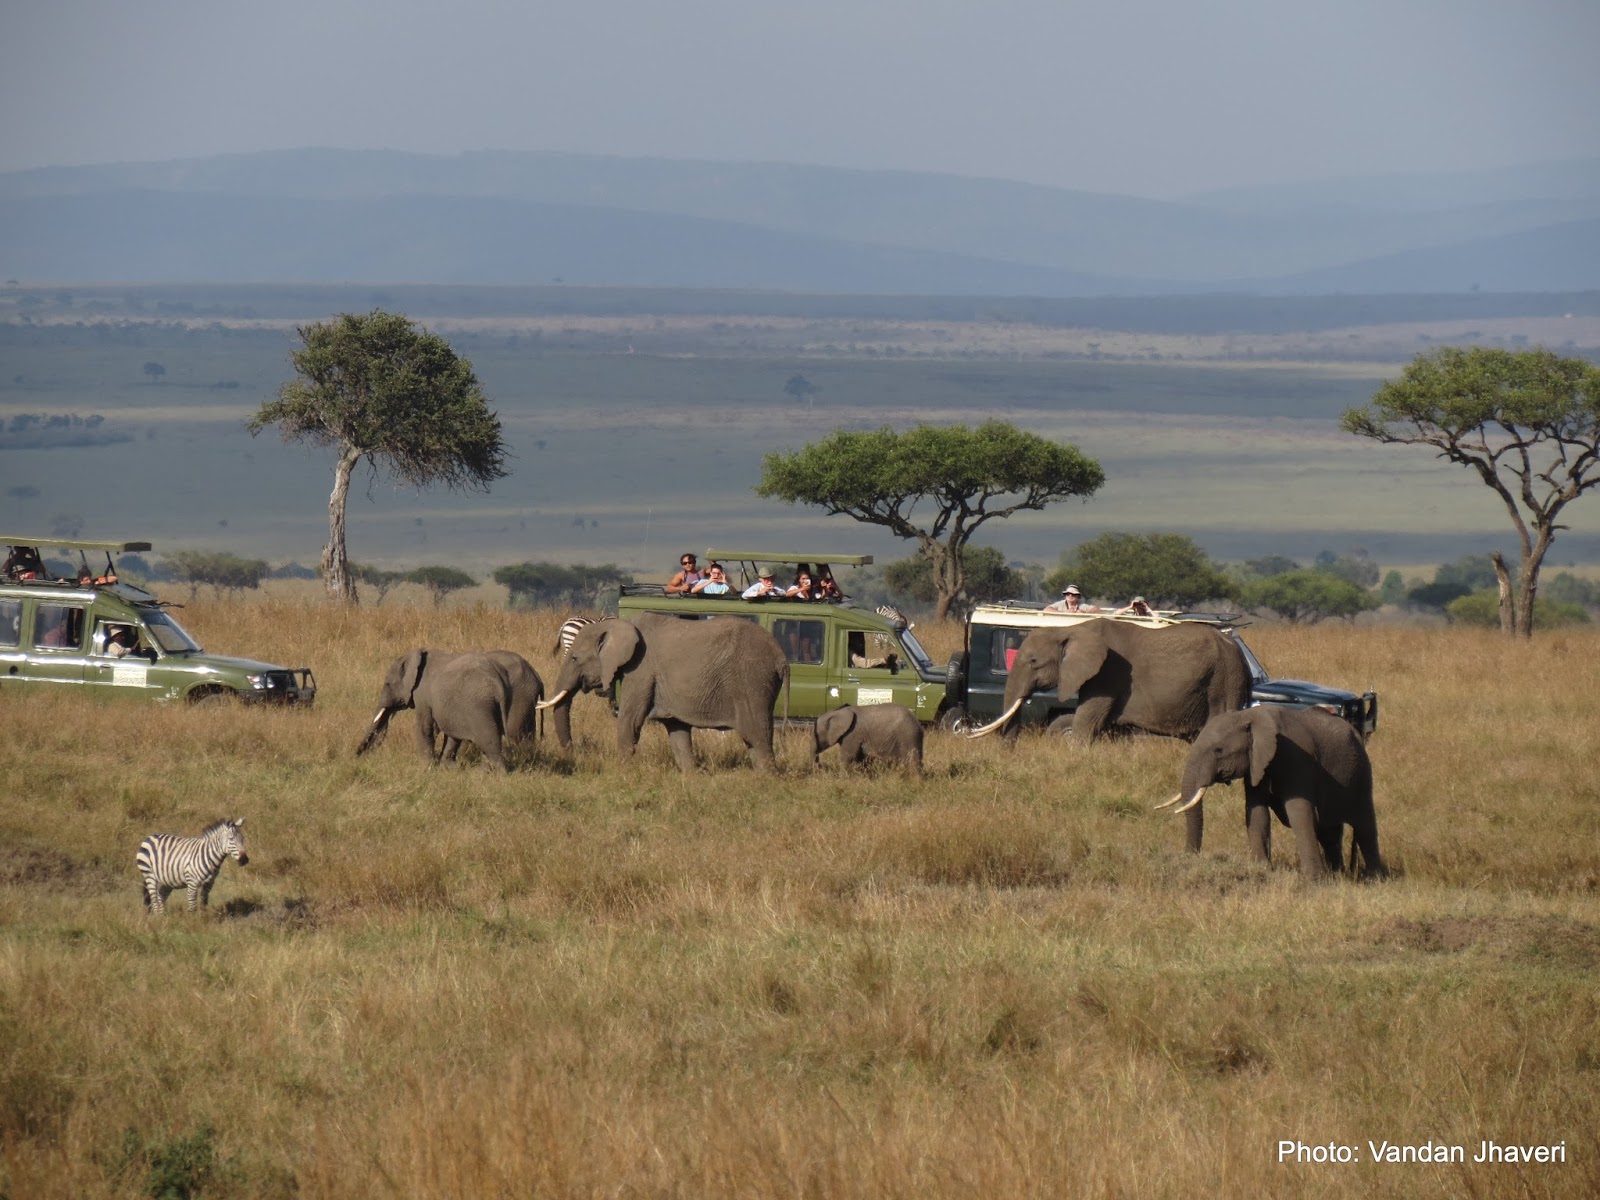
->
[[0, 597, 1600, 1200]]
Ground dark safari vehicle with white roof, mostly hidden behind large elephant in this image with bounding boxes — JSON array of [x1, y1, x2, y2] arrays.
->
[[946, 600, 1378, 738]]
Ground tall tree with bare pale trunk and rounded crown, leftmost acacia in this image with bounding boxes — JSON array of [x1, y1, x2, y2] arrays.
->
[[250, 309, 506, 603]]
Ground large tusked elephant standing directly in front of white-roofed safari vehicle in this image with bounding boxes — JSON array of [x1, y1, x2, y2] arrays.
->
[[973, 618, 1250, 845]]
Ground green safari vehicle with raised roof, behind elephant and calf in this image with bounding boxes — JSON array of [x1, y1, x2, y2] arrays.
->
[[618, 550, 944, 723]]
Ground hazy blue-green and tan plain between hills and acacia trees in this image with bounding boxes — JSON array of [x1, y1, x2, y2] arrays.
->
[[0, 286, 1600, 573]]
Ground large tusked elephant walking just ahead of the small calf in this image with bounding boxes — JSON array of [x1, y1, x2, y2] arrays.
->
[[539, 613, 789, 771]]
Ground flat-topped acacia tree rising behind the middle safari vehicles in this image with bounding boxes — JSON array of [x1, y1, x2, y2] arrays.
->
[[755, 421, 1106, 621]]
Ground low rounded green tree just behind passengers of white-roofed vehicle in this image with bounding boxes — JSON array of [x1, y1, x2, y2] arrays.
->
[[1045, 533, 1237, 608]]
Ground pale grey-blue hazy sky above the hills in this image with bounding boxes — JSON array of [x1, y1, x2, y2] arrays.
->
[[0, 0, 1600, 197]]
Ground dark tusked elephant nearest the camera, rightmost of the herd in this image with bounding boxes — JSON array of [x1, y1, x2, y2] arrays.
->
[[1157, 704, 1389, 878]]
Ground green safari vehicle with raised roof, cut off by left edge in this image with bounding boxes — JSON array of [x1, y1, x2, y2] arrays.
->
[[0, 536, 317, 704]]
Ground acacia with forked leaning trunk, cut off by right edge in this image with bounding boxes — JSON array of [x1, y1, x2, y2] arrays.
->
[[1344, 346, 1600, 637]]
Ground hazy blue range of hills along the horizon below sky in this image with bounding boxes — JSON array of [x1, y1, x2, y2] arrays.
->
[[0, 150, 1600, 296]]
